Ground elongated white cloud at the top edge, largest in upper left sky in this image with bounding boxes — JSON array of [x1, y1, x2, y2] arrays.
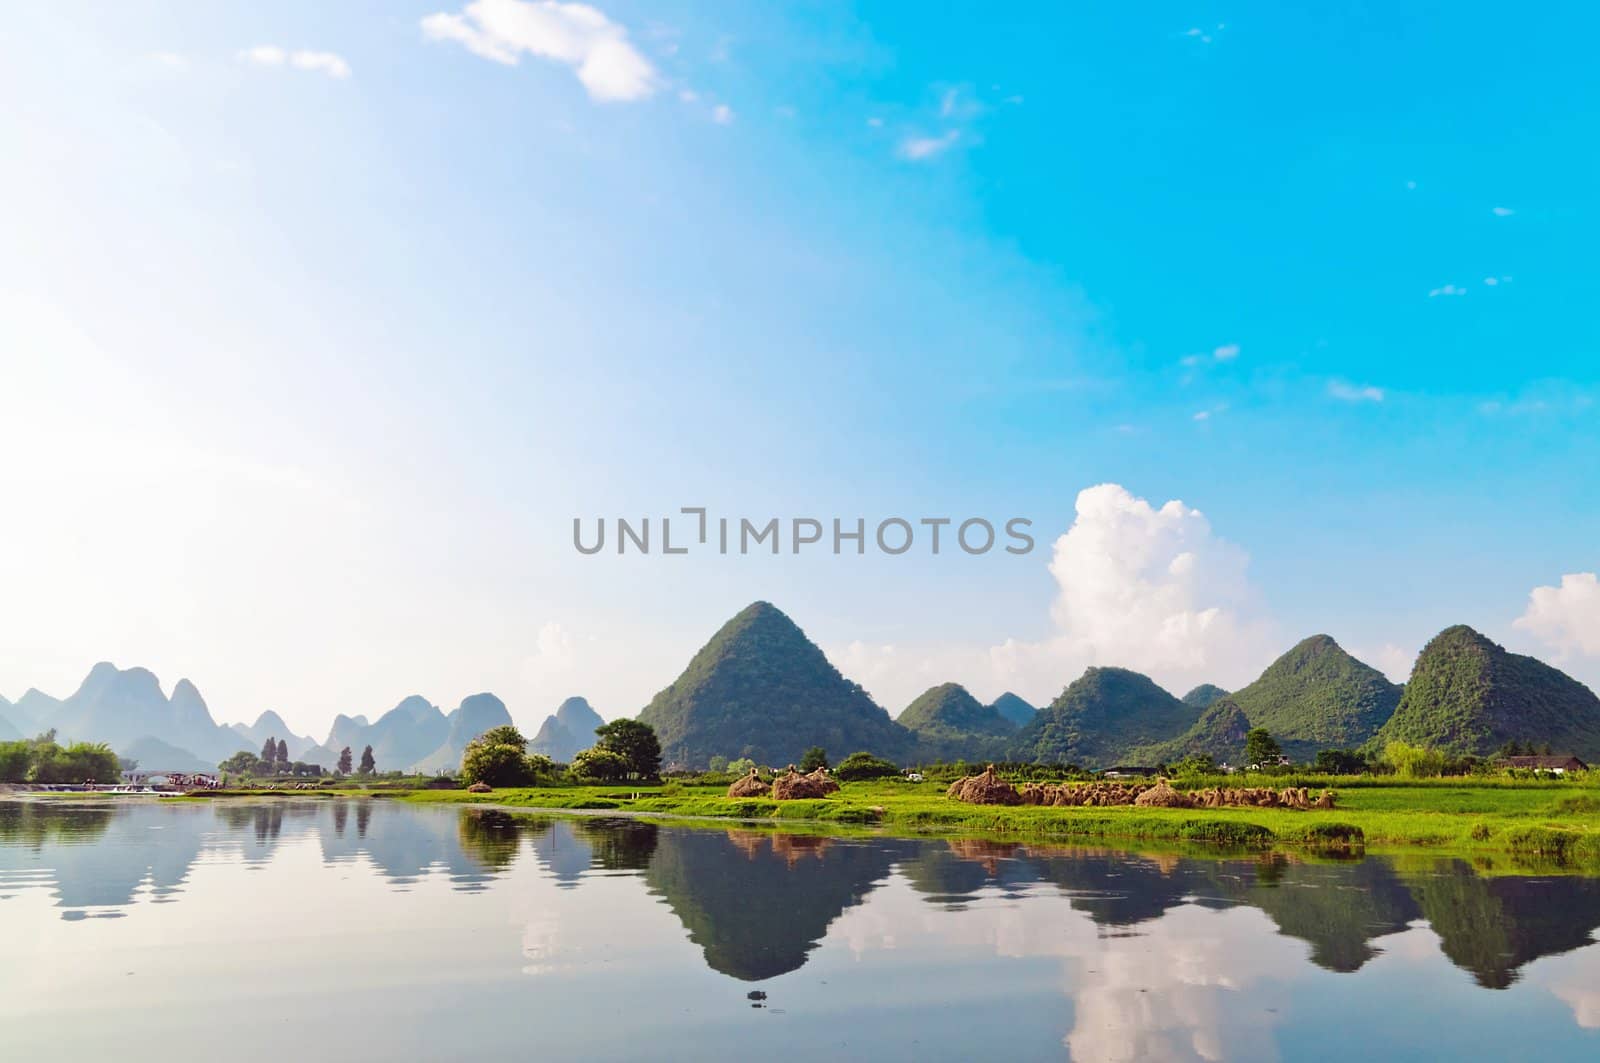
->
[[422, 0, 659, 102]]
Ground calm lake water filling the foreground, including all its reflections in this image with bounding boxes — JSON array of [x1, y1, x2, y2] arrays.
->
[[0, 800, 1600, 1063]]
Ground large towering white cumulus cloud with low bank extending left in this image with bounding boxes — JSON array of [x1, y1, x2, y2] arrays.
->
[[829, 483, 1277, 711]]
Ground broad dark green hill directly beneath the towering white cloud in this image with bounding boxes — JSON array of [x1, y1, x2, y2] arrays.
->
[[1013, 668, 1200, 767]]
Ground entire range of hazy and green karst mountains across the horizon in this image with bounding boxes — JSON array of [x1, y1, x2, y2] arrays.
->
[[0, 602, 1600, 772]]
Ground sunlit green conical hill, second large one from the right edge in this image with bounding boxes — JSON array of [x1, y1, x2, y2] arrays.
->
[[1229, 636, 1400, 760]]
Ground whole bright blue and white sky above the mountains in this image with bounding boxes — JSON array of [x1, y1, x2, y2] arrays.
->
[[0, 0, 1600, 738]]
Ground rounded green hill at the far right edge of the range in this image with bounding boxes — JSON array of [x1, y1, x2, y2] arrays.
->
[[1378, 626, 1600, 760]]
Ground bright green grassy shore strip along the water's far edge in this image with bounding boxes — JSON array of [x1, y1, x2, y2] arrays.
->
[[393, 780, 1600, 869]]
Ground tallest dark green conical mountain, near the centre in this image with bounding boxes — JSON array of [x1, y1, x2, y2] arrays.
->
[[638, 602, 912, 767]]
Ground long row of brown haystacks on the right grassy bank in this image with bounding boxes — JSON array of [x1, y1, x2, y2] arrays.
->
[[946, 765, 1334, 810]]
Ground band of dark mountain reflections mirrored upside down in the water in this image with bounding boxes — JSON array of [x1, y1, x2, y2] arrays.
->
[[0, 799, 1600, 989]]
